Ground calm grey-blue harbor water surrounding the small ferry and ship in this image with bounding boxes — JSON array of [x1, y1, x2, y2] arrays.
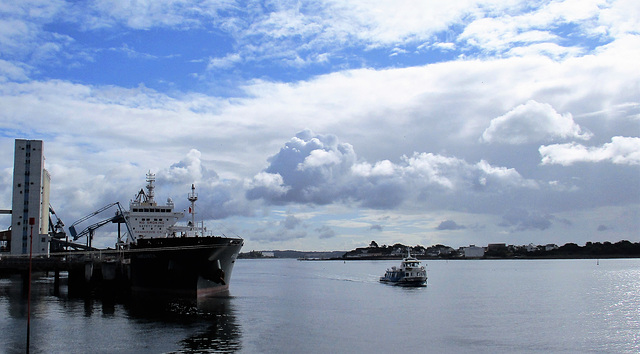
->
[[0, 259, 640, 353]]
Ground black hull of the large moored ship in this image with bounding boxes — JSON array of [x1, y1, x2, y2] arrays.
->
[[129, 236, 243, 298]]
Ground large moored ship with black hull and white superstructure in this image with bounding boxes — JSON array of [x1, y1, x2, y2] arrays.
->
[[122, 173, 244, 298]]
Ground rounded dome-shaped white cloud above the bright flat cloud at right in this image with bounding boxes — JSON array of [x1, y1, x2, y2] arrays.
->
[[482, 100, 592, 144]]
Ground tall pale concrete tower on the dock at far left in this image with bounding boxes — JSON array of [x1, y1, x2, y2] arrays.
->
[[10, 139, 51, 254]]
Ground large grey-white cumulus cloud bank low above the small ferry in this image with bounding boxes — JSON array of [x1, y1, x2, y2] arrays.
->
[[247, 130, 538, 209]]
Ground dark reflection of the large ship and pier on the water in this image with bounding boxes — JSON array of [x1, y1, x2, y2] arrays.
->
[[0, 277, 242, 353]]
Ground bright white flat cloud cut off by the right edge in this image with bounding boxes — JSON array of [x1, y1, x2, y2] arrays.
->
[[539, 136, 640, 166]]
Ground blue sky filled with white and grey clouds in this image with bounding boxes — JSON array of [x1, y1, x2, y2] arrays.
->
[[0, 0, 640, 251]]
